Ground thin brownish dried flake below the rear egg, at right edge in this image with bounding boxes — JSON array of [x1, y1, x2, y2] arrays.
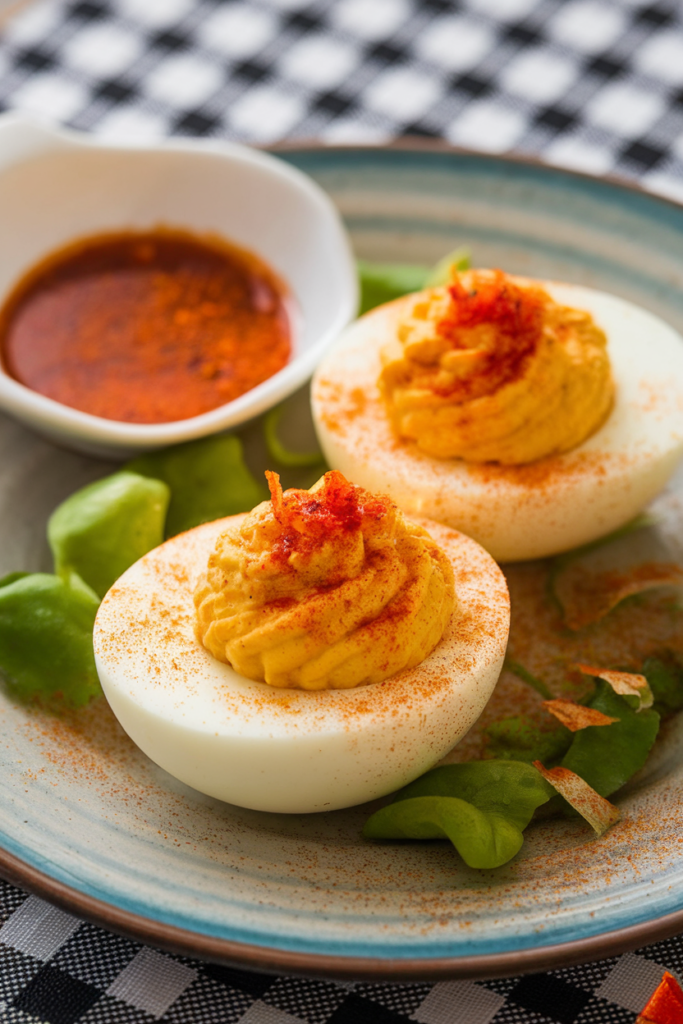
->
[[550, 517, 683, 630]]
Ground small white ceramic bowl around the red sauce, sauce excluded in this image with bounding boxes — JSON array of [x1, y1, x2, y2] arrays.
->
[[0, 115, 357, 457]]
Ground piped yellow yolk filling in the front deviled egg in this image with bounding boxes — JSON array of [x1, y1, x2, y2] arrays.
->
[[195, 472, 455, 690]]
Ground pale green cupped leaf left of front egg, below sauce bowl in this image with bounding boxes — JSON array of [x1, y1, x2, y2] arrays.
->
[[47, 471, 170, 598]]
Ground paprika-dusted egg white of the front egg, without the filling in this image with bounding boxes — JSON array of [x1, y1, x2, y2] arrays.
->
[[94, 516, 509, 812]]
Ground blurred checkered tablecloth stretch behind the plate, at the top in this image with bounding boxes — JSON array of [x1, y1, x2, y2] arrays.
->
[[0, 0, 683, 196]]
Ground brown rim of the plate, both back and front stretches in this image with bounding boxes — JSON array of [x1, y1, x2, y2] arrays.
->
[[0, 136, 683, 982]]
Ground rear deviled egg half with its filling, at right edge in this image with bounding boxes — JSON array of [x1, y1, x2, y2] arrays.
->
[[312, 270, 683, 561]]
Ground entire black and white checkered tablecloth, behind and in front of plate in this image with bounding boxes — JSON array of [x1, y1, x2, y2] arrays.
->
[[0, 0, 683, 1024]]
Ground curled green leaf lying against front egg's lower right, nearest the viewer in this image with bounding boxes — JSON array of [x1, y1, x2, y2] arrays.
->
[[362, 761, 554, 868]]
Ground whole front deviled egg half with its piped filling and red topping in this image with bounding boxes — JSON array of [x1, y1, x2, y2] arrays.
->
[[94, 472, 509, 812]]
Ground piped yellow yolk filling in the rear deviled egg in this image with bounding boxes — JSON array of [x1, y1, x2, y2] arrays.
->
[[379, 270, 614, 465]]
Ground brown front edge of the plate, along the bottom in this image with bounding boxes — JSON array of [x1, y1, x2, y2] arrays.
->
[[0, 848, 683, 982]]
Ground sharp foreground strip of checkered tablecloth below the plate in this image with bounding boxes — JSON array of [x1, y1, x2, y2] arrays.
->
[[0, 883, 683, 1024]]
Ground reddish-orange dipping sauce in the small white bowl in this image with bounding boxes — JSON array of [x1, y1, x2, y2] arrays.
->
[[0, 227, 292, 423]]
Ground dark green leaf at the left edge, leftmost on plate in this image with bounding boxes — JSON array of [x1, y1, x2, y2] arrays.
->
[[0, 572, 101, 708]]
